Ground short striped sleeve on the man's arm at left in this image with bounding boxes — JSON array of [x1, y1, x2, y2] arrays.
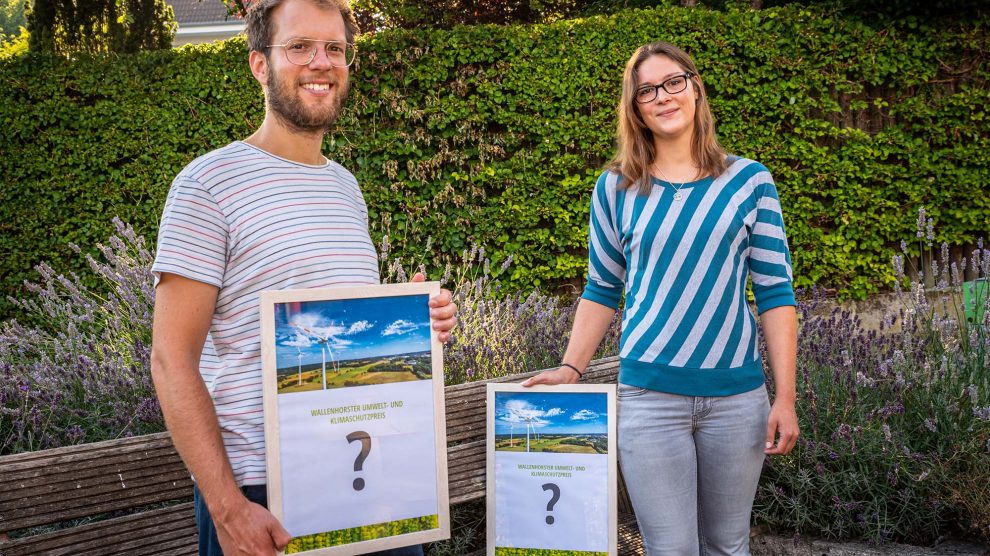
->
[[151, 174, 229, 288]]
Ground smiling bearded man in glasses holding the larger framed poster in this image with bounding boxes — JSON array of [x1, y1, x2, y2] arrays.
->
[[151, 0, 457, 556]]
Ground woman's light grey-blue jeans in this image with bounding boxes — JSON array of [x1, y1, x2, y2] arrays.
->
[[618, 384, 770, 556]]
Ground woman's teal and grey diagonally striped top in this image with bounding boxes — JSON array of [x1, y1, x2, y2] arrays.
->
[[582, 158, 794, 396]]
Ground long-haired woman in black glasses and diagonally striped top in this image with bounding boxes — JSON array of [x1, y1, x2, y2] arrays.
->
[[524, 42, 798, 556]]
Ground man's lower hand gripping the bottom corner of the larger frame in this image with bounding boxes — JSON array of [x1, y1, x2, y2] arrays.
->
[[210, 497, 292, 556]]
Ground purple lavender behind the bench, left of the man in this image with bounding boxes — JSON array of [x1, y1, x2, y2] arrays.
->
[[0, 219, 164, 454]]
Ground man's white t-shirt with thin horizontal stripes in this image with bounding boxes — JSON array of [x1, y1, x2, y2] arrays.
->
[[152, 141, 379, 486]]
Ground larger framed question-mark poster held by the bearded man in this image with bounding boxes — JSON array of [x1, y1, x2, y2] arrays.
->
[[261, 282, 450, 556]]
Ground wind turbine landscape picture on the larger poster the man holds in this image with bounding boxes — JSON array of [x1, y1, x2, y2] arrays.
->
[[275, 294, 432, 394]]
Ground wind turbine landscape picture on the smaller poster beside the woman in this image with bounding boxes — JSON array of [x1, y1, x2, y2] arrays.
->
[[495, 392, 608, 454]]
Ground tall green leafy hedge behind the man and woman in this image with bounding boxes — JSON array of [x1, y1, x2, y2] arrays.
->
[[0, 7, 990, 315]]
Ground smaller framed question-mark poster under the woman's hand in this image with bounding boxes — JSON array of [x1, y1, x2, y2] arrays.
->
[[487, 384, 618, 556]]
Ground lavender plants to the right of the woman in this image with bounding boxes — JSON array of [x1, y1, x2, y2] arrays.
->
[[754, 212, 990, 543]]
